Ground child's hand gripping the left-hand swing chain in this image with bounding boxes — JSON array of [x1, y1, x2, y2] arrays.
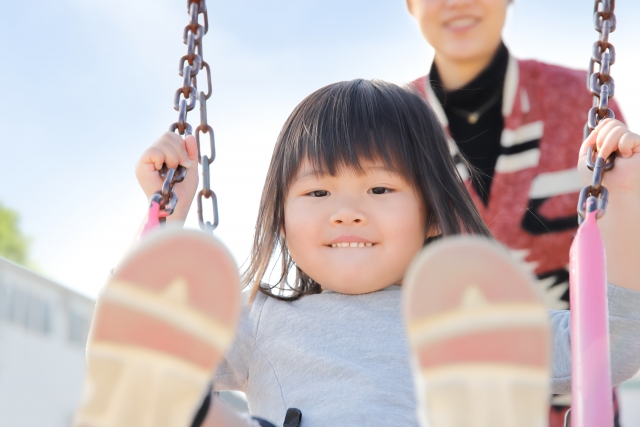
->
[[136, 132, 198, 221]]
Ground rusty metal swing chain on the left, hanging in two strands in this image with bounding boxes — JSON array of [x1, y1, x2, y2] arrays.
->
[[154, 0, 218, 232]]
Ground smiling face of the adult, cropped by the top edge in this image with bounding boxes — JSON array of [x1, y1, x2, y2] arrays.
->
[[407, 0, 511, 61]]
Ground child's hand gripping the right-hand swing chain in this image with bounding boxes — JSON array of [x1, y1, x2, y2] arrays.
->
[[578, 119, 640, 196]]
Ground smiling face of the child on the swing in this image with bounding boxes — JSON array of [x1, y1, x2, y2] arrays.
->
[[284, 161, 427, 294]]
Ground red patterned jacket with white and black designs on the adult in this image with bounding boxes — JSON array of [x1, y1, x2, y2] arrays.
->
[[413, 57, 622, 309]]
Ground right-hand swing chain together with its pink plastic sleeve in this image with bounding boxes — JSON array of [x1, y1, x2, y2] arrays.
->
[[565, 0, 616, 427]]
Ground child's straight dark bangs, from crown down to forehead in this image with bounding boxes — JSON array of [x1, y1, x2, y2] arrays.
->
[[285, 80, 413, 187]]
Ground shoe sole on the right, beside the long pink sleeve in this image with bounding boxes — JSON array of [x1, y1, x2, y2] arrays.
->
[[403, 236, 550, 427]]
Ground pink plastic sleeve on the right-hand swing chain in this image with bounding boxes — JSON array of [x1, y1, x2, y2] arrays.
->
[[570, 201, 613, 427]]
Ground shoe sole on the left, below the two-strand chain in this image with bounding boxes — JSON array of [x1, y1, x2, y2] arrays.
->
[[73, 230, 240, 427]]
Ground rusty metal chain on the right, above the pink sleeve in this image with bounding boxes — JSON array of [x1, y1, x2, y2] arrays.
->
[[578, 0, 616, 224]]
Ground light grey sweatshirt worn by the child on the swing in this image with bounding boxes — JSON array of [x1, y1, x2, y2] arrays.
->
[[213, 285, 640, 427]]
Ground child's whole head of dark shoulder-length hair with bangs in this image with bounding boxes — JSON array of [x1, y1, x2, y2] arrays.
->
[[243, 79, 491, 300]]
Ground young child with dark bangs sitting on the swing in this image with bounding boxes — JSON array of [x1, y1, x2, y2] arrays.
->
[[76, 80, 640, 427]]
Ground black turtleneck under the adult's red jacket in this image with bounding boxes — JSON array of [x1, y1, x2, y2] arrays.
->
[[429, 44, 509, 205]]
